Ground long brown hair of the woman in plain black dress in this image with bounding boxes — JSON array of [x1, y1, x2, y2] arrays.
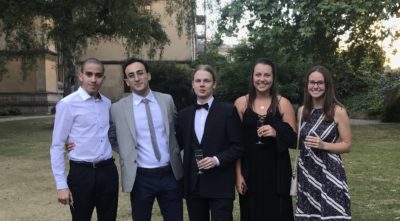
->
[[247, 58, 279, 115]]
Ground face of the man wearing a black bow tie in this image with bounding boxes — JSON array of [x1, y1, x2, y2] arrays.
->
[[192, 69, 216, 102]]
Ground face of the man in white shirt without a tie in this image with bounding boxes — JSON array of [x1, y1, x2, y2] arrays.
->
[[78, 62, 106, 97]]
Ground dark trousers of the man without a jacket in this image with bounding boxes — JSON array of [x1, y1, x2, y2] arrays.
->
[[67, 159, 118, 221]]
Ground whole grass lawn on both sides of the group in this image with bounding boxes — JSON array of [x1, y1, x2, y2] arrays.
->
[[0, 118, 400, 221]]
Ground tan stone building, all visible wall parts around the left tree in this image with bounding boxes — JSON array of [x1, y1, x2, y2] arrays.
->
[[0, 0, 193, 113]]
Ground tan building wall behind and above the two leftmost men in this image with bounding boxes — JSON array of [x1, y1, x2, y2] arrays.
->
[[80, 0, 194, 101]]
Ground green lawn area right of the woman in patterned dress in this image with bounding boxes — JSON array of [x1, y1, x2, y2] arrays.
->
[[343, 124, 400, 221]]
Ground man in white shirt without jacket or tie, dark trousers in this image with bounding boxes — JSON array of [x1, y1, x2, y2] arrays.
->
[[50, 58, 118, 221]]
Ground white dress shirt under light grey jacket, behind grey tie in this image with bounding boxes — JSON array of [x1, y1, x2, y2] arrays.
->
[[132, 91, 170, 168]]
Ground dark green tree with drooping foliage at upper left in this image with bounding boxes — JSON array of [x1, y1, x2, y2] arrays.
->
[[0, 0, 196, 94]]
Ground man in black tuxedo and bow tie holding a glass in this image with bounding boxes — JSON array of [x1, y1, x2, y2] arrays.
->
[[177, 65, 244, 221]]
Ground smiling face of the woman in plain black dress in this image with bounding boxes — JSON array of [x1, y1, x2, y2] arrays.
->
[[253, 63, 274, 93]]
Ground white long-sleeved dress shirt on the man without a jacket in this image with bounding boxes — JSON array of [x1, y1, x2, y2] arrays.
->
[[50, 87, 112, 190]]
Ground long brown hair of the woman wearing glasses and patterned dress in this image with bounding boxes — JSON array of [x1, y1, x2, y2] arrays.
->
[[303, 65, 344, 121]]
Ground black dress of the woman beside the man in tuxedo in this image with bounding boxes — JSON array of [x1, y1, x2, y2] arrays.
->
[[239, 108, 296, 221]]
